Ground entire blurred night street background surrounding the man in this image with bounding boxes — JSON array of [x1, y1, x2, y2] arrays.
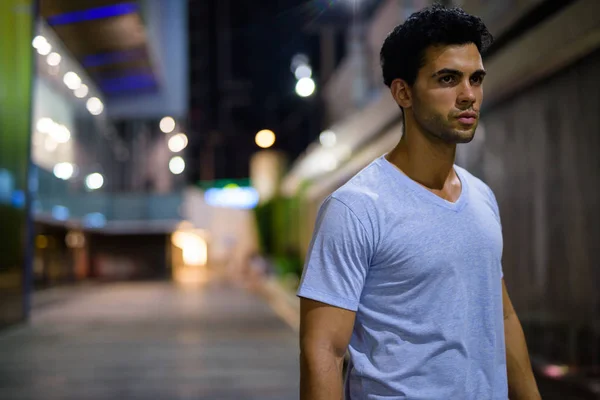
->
[[0, 0, 600, 400]]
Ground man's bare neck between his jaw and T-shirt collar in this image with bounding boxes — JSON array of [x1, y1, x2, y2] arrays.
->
[[387, 112, 456, 190]]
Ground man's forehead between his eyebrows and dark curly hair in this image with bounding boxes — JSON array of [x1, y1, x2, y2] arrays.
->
[[422, 43, 483, 74]]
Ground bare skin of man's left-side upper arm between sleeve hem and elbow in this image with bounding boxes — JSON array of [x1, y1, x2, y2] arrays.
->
[[300, 298, 356, 358]]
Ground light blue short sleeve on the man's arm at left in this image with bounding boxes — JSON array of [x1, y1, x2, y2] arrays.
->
[[297, 197, 373, 311]]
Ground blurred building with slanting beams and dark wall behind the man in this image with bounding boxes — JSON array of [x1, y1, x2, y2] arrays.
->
[[277, 0, 600, 388]]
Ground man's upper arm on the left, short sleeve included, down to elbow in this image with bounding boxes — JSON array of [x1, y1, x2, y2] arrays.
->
[[298, 197, 372, 359]]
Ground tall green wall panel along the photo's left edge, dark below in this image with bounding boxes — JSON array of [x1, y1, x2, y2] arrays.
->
[[0, 0, 33, 327]]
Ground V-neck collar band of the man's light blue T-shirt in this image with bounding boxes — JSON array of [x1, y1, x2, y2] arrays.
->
[[379, 154, 469, 212]]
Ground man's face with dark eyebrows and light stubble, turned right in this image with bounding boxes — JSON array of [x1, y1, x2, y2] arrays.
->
[[411, 44, 485, 143]]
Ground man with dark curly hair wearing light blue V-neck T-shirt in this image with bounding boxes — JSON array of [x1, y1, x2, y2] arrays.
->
[[298, 6, 540, 400]]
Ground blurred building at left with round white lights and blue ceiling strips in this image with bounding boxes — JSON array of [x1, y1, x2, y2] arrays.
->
[[0, 0, 189, 325]]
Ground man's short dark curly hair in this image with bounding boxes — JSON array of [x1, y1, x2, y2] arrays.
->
[[380, 4, 493, 87]]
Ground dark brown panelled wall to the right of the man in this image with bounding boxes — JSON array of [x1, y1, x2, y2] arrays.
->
[[482, 52, 600, 318]]
